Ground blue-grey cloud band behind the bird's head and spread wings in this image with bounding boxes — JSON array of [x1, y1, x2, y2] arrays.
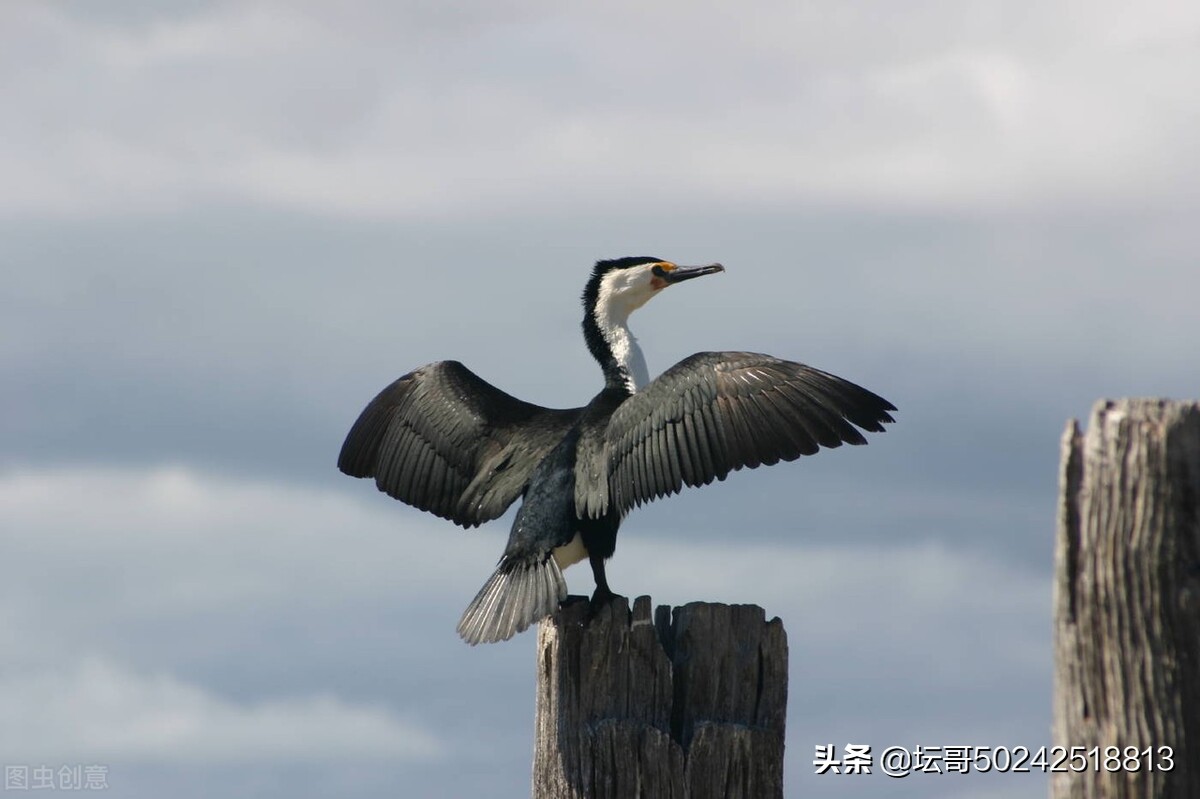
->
[[7, 208, 1200, 568]]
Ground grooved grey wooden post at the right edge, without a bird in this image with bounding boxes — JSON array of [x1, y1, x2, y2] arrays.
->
[[1051, 400, 1200, 799]]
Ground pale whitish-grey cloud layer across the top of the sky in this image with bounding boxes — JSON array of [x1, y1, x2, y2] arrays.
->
[[0, 1, 1200, 216]]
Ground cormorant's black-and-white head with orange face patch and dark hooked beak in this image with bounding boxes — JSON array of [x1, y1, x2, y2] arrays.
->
[[583, 256, 725, 323]]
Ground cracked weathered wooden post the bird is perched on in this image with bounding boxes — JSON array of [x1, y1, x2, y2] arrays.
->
[[533, 596, 787, 799]]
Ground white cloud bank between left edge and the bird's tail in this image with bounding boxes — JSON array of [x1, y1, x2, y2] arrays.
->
[[0, 467, 497, 619]]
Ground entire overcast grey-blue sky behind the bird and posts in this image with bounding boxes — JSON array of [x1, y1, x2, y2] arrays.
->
[[7, 0, 1200, 799]]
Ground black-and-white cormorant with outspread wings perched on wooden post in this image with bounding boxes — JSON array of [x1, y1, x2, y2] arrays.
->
[[337, 257, 896, 645]]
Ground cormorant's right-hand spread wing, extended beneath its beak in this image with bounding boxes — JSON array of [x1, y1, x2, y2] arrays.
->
[[575, 353, 895, 517]]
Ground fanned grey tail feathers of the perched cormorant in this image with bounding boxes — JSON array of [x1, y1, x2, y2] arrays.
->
[[458, 554, 566, 645]]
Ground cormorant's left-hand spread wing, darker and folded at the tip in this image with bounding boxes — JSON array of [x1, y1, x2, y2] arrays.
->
[[337, 361, 580, 527]]
